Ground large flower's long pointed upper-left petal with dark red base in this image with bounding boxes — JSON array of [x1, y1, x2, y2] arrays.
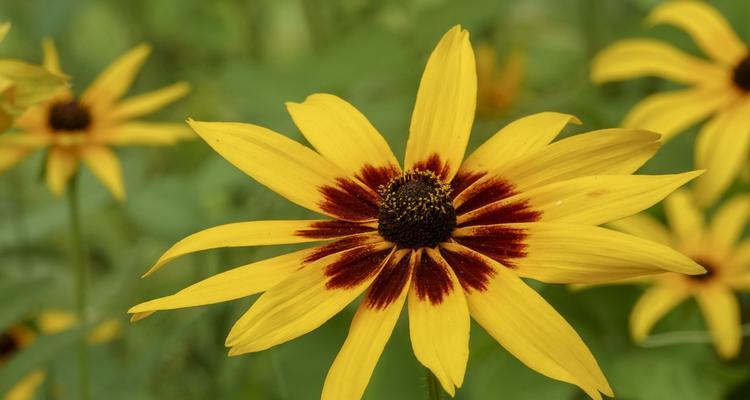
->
[[188, 120, 378, 221]]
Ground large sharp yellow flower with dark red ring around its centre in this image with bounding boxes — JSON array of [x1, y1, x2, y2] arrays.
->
[[129, 26, 703, 400]]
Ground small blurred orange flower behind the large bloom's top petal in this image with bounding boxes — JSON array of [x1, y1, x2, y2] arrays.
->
[[477, 43, 526, 117]]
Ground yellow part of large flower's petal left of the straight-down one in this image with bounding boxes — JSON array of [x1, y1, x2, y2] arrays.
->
[[320, 251, 412, 400]]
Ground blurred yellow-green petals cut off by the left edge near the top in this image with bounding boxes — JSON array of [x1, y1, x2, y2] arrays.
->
[[0, 22, 67, 132]]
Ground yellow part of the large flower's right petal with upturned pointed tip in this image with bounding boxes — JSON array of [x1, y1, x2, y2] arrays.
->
[[458, 172, 701, 225]]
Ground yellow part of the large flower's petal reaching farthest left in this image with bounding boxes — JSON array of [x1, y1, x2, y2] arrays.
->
[[128, 249, 314, 314]]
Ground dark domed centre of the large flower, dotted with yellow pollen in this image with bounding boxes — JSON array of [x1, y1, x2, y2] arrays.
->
[[378, 171, 456, 249]]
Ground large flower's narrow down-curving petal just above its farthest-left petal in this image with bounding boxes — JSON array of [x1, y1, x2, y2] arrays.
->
[[143, 220, 344, 276]]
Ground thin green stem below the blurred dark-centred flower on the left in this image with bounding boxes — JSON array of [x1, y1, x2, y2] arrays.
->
[[68, 174, 90, 400]]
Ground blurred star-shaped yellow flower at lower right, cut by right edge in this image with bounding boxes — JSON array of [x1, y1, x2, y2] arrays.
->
[[611, 191, 750, 358]]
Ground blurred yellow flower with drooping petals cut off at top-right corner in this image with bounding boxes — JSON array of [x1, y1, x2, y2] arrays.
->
[[592, 1, 750, 205]]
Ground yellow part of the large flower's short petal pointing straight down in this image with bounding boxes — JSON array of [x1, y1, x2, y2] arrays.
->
[[409, 249, 470, 396]]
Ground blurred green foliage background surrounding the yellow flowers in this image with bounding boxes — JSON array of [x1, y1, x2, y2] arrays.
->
[[0, 0, 750, 400]]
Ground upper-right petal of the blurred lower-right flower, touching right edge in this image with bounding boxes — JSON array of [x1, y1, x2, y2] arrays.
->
[[709, 194, 750, 251]]
